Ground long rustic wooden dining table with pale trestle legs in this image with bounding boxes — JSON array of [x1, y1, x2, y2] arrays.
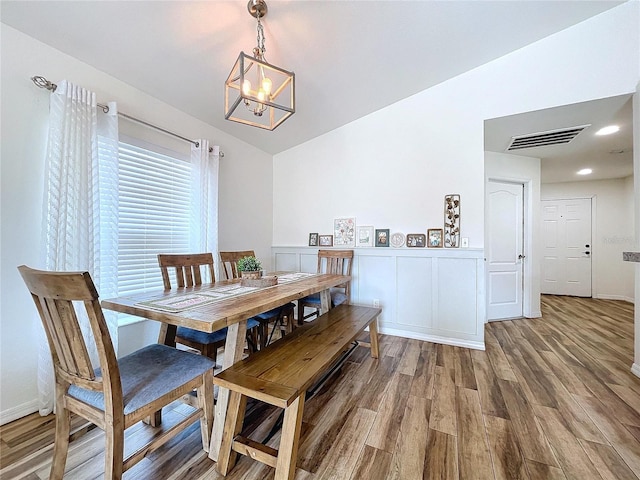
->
[[101, 272, 351, 461]]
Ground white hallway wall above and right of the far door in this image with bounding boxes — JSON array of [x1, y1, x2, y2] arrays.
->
[[541, 177, 634, 302]]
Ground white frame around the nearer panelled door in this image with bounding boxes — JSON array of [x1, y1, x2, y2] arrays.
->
[[484, 175, 542, 323]]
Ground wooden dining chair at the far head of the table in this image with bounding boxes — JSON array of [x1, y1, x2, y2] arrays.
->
[[298, 250, 353, 325]]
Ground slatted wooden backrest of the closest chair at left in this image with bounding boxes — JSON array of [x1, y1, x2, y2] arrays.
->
[[18, 265, 122, 404]]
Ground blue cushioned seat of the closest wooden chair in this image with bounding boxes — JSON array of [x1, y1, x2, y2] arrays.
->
[[69, 344, 215, 415]]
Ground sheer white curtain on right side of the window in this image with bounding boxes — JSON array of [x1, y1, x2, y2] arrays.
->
[[191, 140, 220, 278]]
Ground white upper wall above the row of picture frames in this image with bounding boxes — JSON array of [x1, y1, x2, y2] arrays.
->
[[273, 2, 640, 248]]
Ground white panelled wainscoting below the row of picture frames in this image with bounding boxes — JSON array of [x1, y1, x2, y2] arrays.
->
[[271, 246, 486, 350]]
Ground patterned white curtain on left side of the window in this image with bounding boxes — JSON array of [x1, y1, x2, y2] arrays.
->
[[38, 80, 118, 415]]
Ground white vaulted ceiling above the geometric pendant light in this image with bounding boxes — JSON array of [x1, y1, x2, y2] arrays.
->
[[0, 0, 628, 180]]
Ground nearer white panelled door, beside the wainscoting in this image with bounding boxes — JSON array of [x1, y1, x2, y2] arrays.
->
[[486, 181, 524, 320]]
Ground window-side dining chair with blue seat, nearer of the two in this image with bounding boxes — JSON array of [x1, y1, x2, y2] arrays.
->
[[158, 253, 260, 362]]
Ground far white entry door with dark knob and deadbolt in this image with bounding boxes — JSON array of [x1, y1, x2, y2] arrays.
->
[[540, 198, 592, 297]]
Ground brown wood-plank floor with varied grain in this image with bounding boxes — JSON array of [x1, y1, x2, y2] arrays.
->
[[0, 296, 640, 480]]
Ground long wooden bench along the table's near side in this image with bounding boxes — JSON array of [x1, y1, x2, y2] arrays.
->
[[214, 304, 381, 480]]
